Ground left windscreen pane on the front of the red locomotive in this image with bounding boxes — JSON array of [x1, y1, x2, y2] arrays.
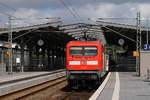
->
[[70, 46, 83, 56]]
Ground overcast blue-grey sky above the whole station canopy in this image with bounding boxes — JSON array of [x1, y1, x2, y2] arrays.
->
[[0, 0, 150, 25]]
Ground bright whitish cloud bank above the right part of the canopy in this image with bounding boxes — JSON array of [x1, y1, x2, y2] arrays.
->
[[67, 3, 150, 24]]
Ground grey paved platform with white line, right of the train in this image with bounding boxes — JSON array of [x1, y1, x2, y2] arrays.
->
[[90, 72, 150, 100]]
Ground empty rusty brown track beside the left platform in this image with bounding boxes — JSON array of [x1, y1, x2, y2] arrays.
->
[[0, 76, 66, 100]]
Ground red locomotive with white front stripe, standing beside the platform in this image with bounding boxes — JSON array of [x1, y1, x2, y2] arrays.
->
[[66, 41, 109, 86]]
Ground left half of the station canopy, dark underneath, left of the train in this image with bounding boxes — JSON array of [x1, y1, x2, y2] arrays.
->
[[0, 21, 73, 46]]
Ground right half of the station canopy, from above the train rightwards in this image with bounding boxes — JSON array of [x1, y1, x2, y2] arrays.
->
[[61, 21, 150, 51]]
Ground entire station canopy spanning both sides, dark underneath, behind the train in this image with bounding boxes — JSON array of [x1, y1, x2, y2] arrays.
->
[[0, 21, 149, 51]]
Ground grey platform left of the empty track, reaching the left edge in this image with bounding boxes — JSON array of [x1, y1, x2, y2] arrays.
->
[[0, 69, 65, 97]]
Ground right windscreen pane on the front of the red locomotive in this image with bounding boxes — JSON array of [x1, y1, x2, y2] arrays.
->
[[84, 47, 97, 56]]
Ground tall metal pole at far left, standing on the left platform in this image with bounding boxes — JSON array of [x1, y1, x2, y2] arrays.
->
[[8, 16, 13, 73]]
